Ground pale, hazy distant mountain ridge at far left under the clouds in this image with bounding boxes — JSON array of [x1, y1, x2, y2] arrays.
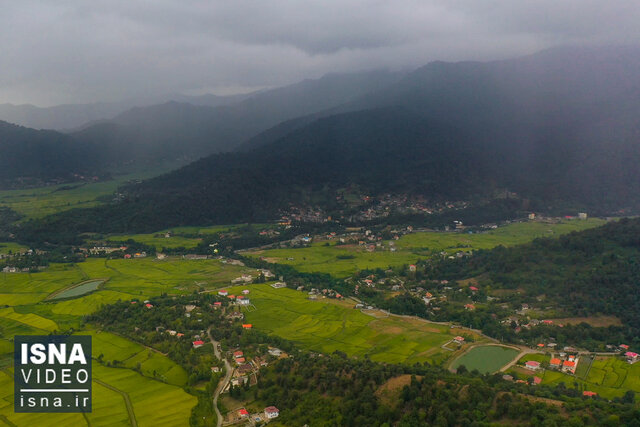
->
[[0, 94, 252, 131]]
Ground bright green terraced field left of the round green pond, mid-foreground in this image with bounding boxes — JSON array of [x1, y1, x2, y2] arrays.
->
[[229, 284, 482, 363]]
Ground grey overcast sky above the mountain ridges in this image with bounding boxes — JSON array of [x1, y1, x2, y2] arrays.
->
[[0, 0, 640, 106]]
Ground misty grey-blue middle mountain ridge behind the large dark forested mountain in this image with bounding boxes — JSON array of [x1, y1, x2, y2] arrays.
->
[[71, 71, 401, 161]]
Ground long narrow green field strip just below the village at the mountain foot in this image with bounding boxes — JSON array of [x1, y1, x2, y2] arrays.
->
[[244, 218, 605, 277]]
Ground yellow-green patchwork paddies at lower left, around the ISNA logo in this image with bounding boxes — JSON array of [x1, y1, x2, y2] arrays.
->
[[0, 258, 249, 426]]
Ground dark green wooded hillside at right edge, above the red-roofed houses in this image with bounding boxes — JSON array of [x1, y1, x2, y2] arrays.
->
[[427, 218, 640, 341]]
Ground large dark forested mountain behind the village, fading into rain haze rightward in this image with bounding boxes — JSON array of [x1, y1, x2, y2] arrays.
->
[[15, 48, 640, 241]]
